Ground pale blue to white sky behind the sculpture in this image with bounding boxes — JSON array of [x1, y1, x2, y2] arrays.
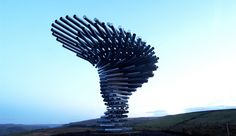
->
[[0, 0, 236, 124]]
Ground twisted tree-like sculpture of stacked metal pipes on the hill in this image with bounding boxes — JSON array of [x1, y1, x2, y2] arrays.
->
[[51, 15, 158, 131]]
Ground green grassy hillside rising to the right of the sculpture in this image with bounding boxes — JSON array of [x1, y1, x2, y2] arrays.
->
[[134, 109, 236, 136]]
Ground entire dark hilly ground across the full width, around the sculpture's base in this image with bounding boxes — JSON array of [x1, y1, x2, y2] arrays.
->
[[0, 109, 236, 136]]
